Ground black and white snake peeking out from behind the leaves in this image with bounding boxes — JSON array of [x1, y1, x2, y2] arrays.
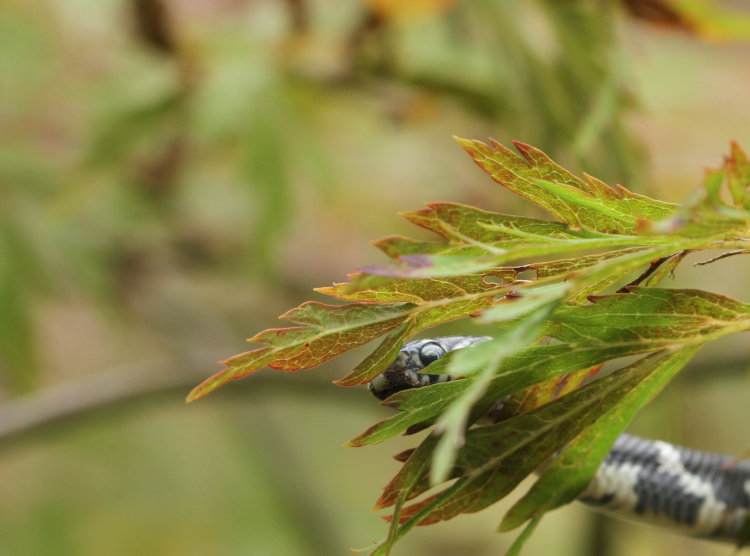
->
[[369, 336, 750, 545]]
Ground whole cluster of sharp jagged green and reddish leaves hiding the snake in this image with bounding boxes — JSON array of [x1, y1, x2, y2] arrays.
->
[[188, 139, 750, 554]]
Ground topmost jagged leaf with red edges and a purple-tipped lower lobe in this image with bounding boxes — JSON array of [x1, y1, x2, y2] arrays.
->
[[363, 139, 750, 284]]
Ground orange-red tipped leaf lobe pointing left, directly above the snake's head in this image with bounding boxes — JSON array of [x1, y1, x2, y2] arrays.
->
[[187, 273, 506, 402]]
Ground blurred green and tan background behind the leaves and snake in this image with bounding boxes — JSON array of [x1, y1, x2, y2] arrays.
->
[[0, 0, 750, 556]]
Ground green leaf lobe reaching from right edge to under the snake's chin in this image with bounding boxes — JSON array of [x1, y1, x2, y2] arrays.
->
[[370, 288, 750, 499]]
